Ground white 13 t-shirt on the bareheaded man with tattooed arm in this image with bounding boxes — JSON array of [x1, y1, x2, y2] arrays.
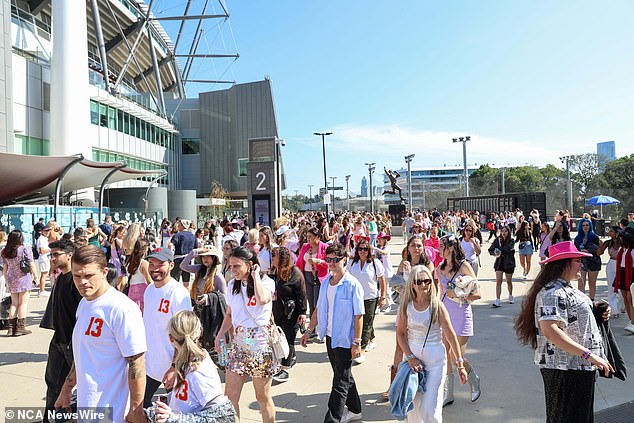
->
[[73, 288, 147, 422]]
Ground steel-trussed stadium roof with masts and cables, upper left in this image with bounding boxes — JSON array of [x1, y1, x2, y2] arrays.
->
[[19, 0, 239, 115]]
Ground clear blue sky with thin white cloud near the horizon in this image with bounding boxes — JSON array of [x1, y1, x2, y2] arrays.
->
[[156, 0, 634, 195]]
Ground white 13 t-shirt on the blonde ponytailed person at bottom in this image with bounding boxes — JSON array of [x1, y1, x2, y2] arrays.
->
[[169, 351, 228, 414]]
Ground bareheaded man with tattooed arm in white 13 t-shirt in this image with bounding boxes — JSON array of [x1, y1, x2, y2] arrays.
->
[[55, 245, 147, 422]]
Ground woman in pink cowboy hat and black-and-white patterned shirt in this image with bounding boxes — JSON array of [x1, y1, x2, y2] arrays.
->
[[515, 241, 614, 423]]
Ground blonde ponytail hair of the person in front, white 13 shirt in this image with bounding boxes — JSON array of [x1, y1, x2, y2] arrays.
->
[[167, 310, 206, 389]]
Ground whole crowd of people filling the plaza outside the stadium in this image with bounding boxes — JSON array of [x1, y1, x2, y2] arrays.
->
[[0, 209, 634, 422]]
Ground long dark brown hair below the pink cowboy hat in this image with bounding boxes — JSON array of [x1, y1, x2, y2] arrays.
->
[[513, 259, 572, 349]]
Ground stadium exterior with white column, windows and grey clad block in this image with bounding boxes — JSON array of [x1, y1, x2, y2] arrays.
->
[[0, 0, 278, 217]]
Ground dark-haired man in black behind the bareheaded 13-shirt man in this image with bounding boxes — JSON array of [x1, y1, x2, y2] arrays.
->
[[44, 239, 82, 421]]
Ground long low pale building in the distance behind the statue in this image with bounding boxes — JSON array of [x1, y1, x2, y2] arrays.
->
[[379, 166, 478, 207]]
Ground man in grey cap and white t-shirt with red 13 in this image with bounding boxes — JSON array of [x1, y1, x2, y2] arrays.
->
[[143, 248, 192, 408]]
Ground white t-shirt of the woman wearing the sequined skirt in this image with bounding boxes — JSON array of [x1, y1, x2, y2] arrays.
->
[[227, 275, 275, 328]]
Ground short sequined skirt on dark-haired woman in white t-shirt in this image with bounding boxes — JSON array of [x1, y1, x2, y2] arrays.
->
[[227, 326, 280, 378]]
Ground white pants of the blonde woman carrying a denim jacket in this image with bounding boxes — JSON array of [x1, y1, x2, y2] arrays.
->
[[407, 342, 447, 423]]
